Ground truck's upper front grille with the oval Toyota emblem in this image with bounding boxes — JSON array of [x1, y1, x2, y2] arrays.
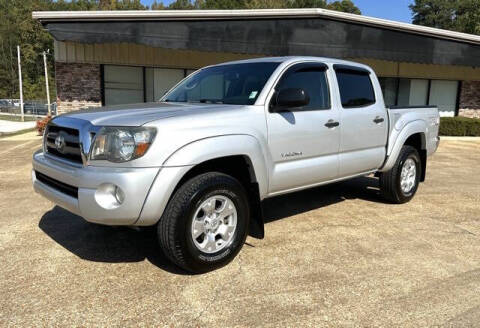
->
[[45, 125, 82, 164]]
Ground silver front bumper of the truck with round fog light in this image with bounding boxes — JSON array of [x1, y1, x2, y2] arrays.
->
[[32, 151, 160, 225]]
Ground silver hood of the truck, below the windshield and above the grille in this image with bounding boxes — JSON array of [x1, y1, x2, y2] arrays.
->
[[61, 102, 242, 126]]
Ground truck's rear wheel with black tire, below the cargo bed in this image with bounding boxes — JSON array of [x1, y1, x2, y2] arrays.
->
[[380, 145, 422, 204]]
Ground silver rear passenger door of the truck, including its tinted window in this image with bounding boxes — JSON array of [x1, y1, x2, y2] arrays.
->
[[334, 65, 388, 177]]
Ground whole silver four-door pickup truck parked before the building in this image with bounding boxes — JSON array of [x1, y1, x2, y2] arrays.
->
[[32, 57, 439, 272]]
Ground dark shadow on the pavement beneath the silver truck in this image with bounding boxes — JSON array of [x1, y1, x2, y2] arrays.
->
[[39, 177, 381, 275]]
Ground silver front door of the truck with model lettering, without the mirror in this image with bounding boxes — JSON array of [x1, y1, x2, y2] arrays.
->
[[267, 62, 340, 194]]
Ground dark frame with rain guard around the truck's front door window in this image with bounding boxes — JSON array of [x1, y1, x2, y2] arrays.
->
[[268, 62, 333, 113]]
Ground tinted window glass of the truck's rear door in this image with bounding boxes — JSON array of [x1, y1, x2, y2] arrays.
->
[[335, 69, 375, 108]]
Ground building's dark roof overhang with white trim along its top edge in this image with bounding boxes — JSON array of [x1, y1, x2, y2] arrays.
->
[[32, 8, 480, 67]]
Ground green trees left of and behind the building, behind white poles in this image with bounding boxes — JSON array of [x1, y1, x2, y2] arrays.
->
[[0, 0, 148, 100]]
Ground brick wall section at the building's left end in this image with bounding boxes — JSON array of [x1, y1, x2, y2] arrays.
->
[[55, 62, 102, 113]]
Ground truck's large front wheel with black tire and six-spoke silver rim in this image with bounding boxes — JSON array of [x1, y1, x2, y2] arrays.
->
[[157, 172, 250, 273]]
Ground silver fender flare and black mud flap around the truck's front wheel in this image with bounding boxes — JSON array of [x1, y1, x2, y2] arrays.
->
[[138, 135, 268, 238]]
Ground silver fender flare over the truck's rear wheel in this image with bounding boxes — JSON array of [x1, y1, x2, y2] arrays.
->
[[379, 120, 427, 172]]
